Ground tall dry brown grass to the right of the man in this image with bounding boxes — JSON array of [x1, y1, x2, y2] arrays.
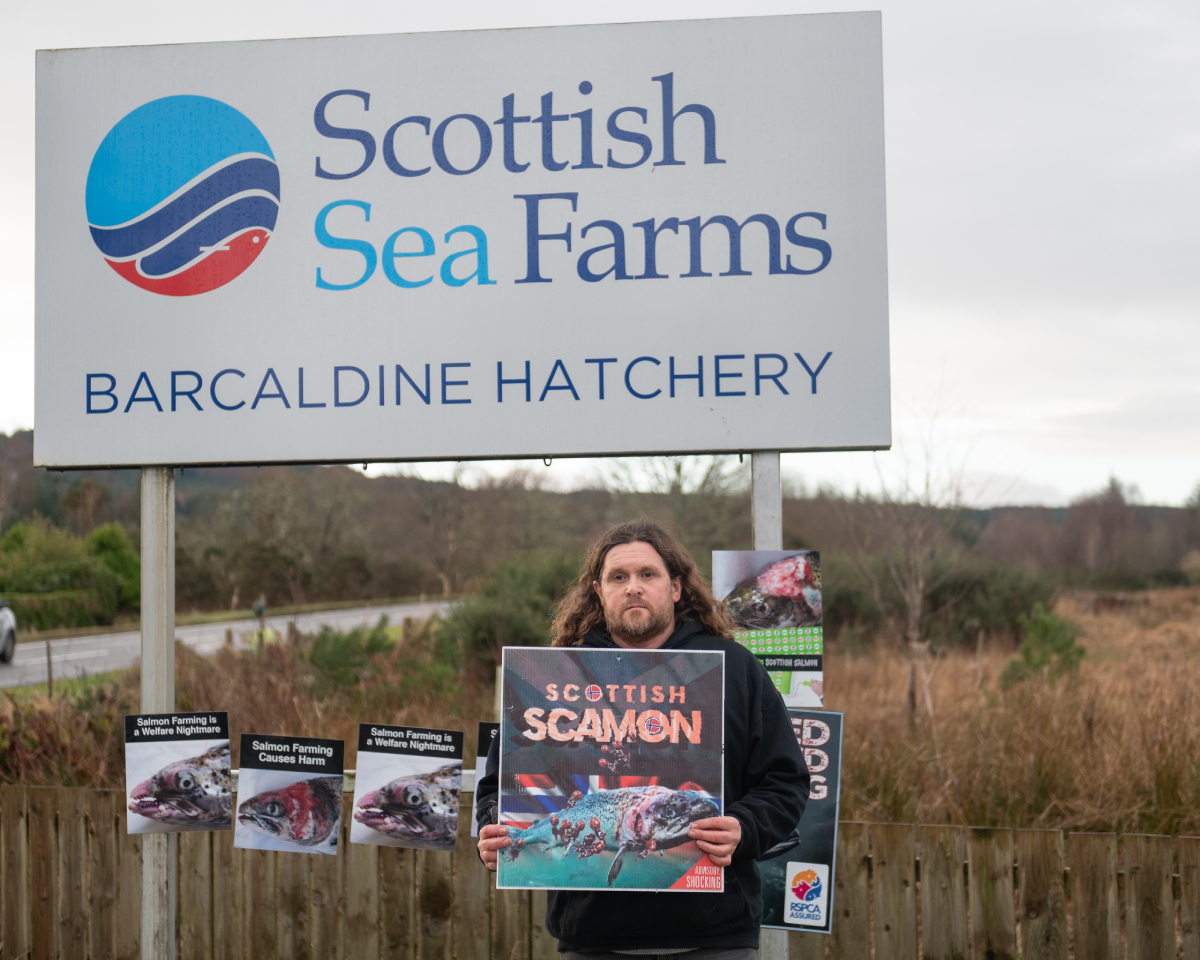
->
[[826, 588, 1200, 834]]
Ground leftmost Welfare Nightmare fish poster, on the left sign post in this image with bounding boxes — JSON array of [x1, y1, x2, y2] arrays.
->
[[125, 710, 233, 833]]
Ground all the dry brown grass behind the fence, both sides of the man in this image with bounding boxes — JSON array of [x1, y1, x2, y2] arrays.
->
[[0, 588, 1200, 834]]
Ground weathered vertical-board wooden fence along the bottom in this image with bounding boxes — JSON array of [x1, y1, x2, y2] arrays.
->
[[0, 787, 1200, 960]]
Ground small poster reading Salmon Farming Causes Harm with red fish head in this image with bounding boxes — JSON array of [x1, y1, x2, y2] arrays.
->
[[233, 733, 346, 856]]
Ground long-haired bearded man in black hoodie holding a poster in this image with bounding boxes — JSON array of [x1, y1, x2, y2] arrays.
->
[[476, 518, 809, 960]]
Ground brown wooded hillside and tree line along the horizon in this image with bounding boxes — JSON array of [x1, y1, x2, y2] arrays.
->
[[0, 432, 1200, 647]]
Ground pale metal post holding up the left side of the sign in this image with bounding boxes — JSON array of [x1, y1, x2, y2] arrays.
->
[[142, 467, 178, 960]]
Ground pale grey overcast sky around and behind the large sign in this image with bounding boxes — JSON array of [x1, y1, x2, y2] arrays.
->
[[0, 0, 1200, 504]]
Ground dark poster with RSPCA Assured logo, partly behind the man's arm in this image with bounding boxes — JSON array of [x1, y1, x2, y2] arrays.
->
[[758, 709, 842, 934]]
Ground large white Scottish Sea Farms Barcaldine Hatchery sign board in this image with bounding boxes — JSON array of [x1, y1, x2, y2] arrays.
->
[[36, 13, 890, 467]]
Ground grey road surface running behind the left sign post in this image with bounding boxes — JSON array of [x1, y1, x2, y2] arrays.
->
[[0, 600, 449, 689]]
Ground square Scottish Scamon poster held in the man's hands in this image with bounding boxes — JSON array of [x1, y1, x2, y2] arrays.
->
[[497, 647, 725, 892]]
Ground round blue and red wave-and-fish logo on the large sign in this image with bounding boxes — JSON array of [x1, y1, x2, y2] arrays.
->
[[86, 96, 280, 296]]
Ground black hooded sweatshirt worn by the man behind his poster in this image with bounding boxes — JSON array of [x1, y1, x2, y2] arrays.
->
[[476, 623, 809, 953]]
